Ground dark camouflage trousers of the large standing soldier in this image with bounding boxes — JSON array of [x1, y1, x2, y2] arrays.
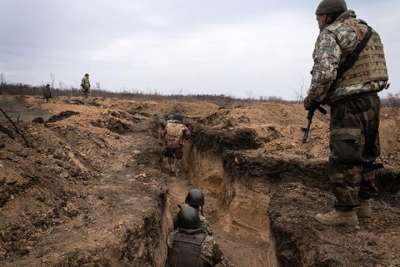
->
[[329, 94, 380, 211]]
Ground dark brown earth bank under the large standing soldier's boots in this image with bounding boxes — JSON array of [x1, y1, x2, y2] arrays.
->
[[269, 184, 400, 266]]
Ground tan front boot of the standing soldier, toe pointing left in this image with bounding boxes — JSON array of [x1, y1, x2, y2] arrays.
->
[[315, 209, 358, 226]]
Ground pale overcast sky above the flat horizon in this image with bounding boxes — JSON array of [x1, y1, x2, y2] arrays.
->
[[0, 0, 400, 99]]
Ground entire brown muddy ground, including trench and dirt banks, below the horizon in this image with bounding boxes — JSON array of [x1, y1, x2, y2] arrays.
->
[[0, 96, 400, 266]]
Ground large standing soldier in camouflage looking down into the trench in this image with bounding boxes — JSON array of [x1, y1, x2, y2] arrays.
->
[[304, 0, 388, 226]]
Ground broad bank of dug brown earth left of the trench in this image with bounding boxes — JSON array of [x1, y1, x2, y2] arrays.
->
[[0, 96, 167, 266]]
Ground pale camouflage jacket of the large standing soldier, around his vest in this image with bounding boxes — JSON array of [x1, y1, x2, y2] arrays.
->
[[308, 10, 387, 103]]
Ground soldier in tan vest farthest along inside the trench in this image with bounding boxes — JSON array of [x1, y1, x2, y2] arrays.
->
[[163, 114, 190, 174]]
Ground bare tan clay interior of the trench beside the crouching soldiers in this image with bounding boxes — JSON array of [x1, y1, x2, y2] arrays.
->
[[168, 144, 278, 267]]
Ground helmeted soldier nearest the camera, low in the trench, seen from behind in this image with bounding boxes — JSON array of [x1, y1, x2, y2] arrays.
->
[[167, 206, 233, 267]]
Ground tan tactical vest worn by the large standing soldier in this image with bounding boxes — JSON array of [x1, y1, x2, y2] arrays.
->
[[333, 18, 389, 91]]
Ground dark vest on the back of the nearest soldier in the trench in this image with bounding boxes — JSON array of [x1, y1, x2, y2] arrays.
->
[[168, 231, 209, 267]]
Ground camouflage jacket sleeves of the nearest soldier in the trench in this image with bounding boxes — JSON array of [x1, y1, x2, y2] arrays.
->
[[168, 230, 234, 267]]
